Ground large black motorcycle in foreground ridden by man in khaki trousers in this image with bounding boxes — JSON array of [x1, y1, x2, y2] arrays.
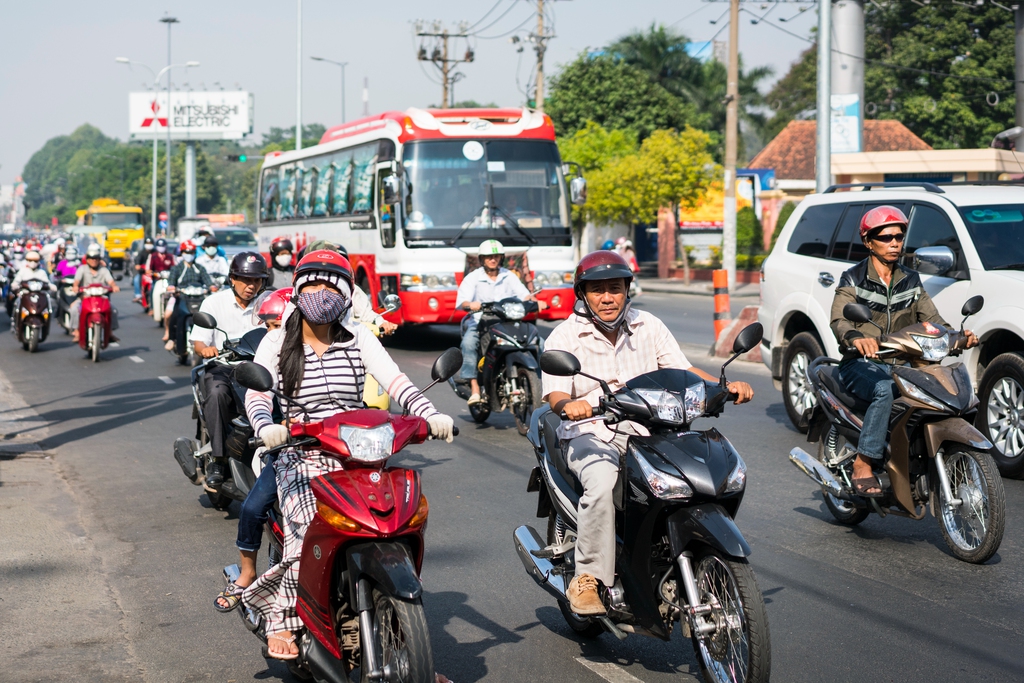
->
[[514, 323, 771, 683]]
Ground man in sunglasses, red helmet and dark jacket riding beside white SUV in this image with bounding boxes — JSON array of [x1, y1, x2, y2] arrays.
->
[[830, 206, 978, 498]]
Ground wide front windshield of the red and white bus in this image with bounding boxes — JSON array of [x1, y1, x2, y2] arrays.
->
[[402, 139, 570, 246]]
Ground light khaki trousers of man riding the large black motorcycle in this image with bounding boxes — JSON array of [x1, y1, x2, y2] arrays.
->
[[562, 434, 629, 586]]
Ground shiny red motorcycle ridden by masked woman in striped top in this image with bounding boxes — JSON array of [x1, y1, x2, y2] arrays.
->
[[230, 348, 462, 683]]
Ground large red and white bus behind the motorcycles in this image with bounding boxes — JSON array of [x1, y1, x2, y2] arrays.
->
[[258, 109, 586, 324]]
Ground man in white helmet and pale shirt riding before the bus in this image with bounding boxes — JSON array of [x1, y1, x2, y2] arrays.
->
[[455, 240, 546, 405]]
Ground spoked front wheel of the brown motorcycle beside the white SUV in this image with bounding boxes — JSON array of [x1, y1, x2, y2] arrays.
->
[[935, 443, 1007, 564]]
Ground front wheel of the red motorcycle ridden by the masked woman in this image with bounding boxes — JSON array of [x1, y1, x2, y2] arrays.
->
[[359, 590, 435, 683]]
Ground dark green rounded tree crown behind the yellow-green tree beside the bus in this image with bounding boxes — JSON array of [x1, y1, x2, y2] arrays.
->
[[545, 53, 700, 139]]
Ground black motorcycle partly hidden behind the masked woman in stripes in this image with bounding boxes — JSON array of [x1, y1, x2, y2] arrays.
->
[[174, 311, 266, 510]]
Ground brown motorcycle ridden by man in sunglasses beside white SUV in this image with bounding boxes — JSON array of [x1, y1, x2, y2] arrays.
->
[[790, 296, 1006, 564]]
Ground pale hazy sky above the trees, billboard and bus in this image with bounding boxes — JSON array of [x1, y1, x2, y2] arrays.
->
[[0, 0, 816, 183]]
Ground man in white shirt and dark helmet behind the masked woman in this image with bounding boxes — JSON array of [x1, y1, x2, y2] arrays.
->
[[189, 252, 267, 486]]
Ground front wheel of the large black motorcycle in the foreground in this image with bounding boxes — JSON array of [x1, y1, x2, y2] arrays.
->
[[690, 548, 771, 683]]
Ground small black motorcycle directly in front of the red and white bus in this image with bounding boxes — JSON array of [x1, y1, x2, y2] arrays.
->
[[449, 298, 543, 435]]
